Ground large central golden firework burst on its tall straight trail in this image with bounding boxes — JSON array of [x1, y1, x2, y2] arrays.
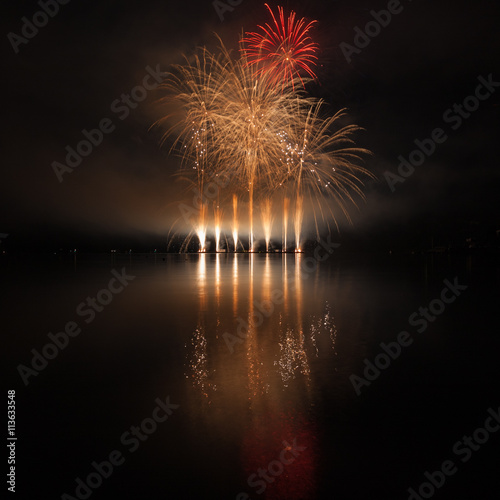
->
[[161, 39, 307, 249]]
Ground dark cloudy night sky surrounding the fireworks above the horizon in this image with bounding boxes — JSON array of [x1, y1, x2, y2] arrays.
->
[[0, 0, 500, 248]]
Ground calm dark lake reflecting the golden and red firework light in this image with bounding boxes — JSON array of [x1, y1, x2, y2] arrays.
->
[[0, 250, 500, 500]]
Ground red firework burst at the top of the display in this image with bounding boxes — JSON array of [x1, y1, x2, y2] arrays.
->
[[241, 3, 318, 86]]
